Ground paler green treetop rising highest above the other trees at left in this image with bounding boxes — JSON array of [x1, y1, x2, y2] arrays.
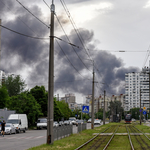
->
[[4, 75, 26, 97]]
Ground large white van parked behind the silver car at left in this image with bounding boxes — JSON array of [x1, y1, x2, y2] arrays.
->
[[7, 114, 28, 133]]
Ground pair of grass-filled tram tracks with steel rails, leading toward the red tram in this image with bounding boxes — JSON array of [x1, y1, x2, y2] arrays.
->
[[75, 125, 150, 150]]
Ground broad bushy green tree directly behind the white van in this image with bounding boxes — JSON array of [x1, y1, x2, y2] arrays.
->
[[8, 93, 43, 126]]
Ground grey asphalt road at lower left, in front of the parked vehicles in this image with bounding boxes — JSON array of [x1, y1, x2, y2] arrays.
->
[[0, 123, 104, 150]]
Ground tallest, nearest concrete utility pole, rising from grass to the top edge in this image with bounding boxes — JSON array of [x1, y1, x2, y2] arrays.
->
[[47, 0, 55, 144]]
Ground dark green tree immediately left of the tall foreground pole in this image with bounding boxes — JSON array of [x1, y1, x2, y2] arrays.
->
[[29, 86, 48, 117]]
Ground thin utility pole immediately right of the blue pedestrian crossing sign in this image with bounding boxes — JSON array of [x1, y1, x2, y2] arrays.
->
[[91, 60, 95, 129]]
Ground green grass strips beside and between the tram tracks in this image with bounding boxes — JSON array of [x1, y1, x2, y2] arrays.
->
[[29, 122, 150, 150]]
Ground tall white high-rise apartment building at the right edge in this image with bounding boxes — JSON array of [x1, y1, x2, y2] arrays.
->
[[125, 67, 150, 111]]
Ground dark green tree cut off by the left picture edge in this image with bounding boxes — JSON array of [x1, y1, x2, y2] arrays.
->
[[0, 86, 9, 108]]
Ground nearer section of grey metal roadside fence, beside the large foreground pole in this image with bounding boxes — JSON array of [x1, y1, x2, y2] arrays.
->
[[53, 125, 73, 140]]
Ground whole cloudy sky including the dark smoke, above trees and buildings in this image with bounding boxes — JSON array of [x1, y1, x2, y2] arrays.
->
[[0, 0, 150, 103]]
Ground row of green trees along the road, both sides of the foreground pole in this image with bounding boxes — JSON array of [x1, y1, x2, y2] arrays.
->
[[0, 75, 75, 126]]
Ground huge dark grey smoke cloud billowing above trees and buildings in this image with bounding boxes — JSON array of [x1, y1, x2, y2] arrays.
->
[[0, 0, 139, 99]]
